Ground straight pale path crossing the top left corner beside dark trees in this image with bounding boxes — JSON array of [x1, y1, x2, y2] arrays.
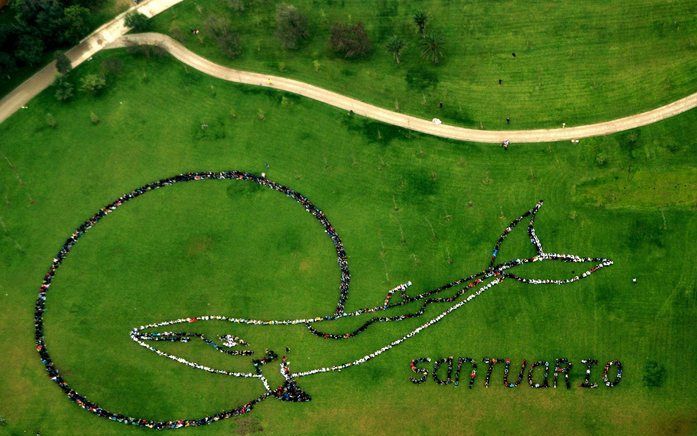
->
[[0, 0, 183, 123]]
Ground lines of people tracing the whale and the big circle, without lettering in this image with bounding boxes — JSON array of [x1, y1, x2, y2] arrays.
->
[[35, 171, 613, 429]]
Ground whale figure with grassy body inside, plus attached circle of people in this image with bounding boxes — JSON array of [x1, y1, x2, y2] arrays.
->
[[35, 171, 613, 429]]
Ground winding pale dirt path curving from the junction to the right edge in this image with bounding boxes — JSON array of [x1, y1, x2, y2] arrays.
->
[[113, 33, 697, 143]]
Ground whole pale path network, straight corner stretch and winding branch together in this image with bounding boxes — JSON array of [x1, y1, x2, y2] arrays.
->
[[0, 26, 697, 143]]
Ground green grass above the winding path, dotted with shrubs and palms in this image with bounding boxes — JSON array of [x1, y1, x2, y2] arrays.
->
[[150, 0, 697, 130]]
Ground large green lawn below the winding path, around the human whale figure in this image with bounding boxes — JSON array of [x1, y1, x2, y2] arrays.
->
[[0, 51, 697, 434]]
